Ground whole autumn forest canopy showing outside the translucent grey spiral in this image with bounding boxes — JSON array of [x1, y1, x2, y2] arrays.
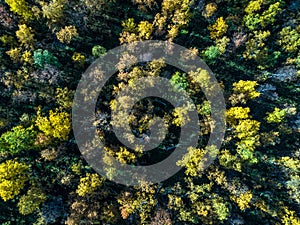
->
[[0, 0, 300, 225]]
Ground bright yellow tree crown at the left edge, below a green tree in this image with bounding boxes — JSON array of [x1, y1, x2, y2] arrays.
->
[[0, 160, 29, 201]]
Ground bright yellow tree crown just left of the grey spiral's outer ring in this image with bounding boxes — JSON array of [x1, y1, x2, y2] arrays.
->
[[35, 109, 71, 141]]
